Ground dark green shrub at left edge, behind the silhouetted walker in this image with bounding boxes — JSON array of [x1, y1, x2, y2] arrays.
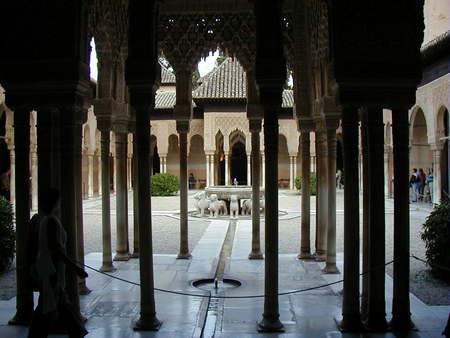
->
[[0, 196, 16, 272]]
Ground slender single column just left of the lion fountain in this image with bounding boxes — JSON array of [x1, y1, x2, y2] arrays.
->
[[177, 120, 191, 259]]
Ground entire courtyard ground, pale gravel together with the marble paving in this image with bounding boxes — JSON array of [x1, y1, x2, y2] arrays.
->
[[0, 191, 449, 338]]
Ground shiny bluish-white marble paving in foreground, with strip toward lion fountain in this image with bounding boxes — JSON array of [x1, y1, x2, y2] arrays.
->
[[0, 220, 449, 338]]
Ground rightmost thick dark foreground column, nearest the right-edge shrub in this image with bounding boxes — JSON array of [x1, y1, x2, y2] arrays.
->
[[390, 109, 414, 331]]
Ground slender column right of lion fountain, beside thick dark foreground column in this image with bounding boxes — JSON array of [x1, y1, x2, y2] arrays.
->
[[248, 119, 264, 259]]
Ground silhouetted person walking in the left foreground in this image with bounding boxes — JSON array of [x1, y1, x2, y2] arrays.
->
[[28, 188, 88, 338]]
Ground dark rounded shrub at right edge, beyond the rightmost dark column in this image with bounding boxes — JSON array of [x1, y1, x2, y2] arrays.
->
[[421, 199, 450, 279]]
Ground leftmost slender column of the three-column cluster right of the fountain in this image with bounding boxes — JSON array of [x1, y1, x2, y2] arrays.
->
[[298, 130, 313, 259]]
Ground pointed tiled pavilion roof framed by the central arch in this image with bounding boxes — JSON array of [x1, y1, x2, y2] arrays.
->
[[192, 58, 247, 99]]
